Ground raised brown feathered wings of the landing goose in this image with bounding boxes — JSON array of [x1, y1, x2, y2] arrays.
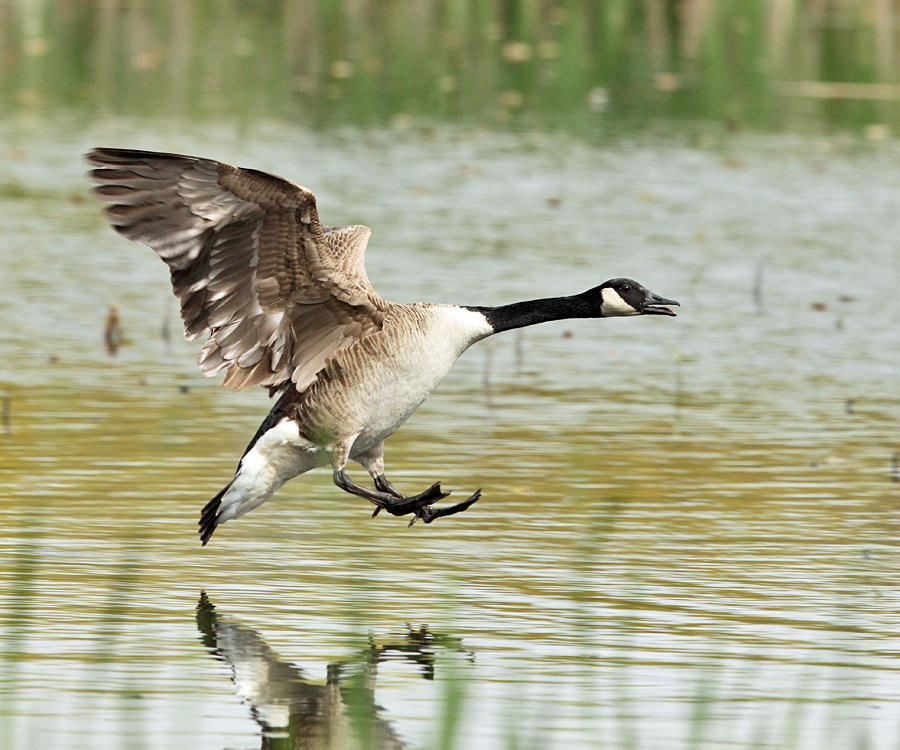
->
[[86, 148, 386, 390]]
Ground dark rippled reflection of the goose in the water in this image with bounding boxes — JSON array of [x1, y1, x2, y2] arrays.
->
[[197, 592, 473, 750]]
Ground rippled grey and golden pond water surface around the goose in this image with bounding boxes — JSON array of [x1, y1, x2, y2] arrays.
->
[[0, 118, 900, 749]]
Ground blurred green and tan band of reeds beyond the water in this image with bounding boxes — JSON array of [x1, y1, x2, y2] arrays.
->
[[0, 0, 900, 135]]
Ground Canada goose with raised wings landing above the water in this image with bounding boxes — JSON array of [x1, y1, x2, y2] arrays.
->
[[86, 148, 678, 545]]
